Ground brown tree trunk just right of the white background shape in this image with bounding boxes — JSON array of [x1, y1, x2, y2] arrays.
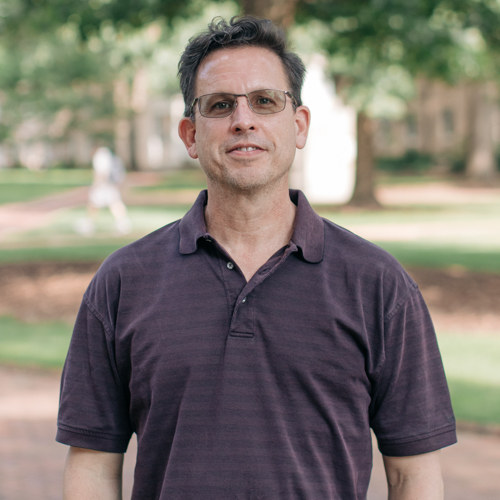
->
[[349, 112, 380, 207]]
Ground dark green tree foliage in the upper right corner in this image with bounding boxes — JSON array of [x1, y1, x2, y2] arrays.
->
[[297, 0, 500, 94]]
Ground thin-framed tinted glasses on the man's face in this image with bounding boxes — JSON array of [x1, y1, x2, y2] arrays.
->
[[190, 89, 297, 118]]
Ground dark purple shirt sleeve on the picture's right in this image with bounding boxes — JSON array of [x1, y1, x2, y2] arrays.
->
[[370, 285, 456, 456]]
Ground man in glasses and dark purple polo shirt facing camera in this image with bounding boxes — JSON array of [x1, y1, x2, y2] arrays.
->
[[58, 18, 455, 500]]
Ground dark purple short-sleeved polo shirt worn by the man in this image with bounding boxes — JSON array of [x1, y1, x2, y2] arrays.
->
[[57, 191, 456, 500]]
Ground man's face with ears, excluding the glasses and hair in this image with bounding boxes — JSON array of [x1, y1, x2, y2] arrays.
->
[[179, 47, 309, 191]]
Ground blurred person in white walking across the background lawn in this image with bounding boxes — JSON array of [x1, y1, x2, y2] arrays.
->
[[77, 146, 130, 234]]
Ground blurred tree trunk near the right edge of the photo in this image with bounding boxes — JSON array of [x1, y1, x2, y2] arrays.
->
[[465, 82, 496, 179]]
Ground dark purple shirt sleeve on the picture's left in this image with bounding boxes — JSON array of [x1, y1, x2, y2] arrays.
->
[[56, 297, 131, 453]]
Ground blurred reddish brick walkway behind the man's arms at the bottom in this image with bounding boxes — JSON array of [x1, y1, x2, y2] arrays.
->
[[0, 366, 500, 500]]
